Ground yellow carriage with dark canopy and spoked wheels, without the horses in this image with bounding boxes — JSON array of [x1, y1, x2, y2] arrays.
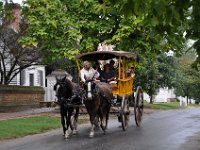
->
[[76, 51, 143, 131]]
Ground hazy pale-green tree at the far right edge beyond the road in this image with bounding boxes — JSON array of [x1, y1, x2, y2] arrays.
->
[[175, 52, 200, 103]]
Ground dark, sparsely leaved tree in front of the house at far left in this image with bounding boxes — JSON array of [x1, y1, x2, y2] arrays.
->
[[0, 3, 40, 84]]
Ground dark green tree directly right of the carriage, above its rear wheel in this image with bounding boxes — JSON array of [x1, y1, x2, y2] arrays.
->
[[135, 53, 175, 103]]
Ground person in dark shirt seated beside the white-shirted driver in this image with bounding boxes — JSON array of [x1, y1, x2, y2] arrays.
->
[[101, 64, 116, 83]]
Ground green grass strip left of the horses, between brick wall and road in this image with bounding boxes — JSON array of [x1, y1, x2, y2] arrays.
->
[[0, 116, 87, 140]]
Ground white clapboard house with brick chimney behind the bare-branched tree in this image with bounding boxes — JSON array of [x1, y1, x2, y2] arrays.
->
[[0, 3, 45, 87]]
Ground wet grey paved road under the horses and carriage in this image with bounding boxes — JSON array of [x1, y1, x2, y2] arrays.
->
[[0, 109, 200, 150]]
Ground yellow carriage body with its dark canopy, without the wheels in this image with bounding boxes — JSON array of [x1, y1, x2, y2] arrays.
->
[[76, 51, 137, 96]]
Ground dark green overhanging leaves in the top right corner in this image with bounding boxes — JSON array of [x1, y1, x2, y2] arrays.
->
[[104, 0, 200, 66]]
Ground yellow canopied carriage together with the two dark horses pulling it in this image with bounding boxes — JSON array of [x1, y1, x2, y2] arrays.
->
[[55, 51, 143, 137]]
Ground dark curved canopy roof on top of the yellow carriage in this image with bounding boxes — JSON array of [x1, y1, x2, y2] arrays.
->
[[76, 51, 137, 61]]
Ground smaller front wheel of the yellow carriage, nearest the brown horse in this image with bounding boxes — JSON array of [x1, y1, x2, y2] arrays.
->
[[120, 96, 130, 131]]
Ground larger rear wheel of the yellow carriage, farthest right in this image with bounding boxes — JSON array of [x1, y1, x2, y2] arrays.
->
[[134, 86, 144, 127]]
